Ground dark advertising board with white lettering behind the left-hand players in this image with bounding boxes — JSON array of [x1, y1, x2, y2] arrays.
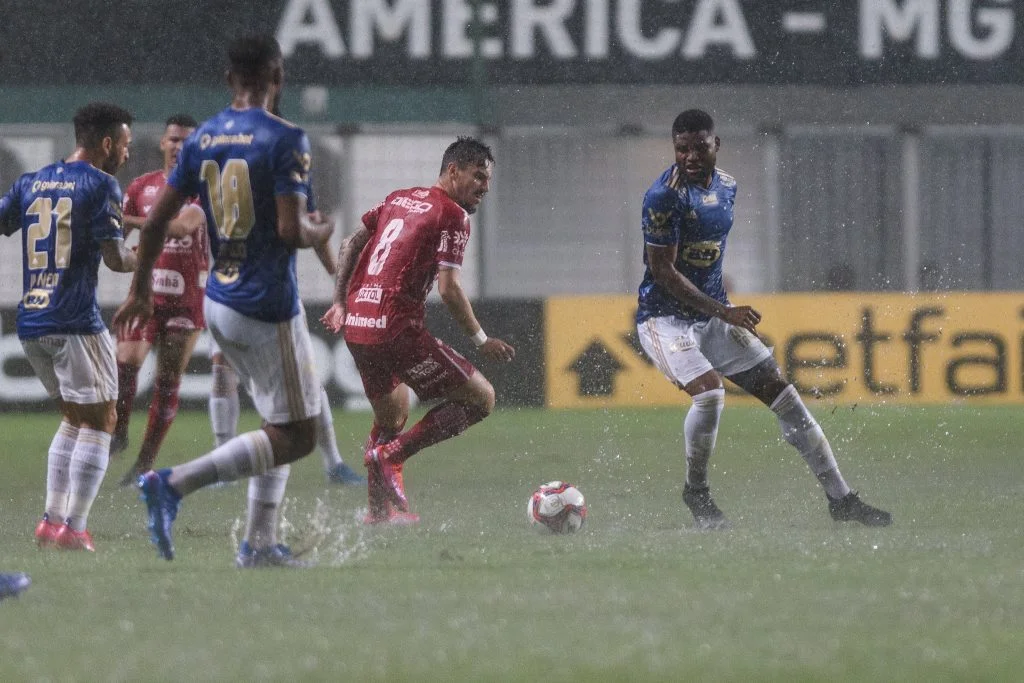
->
[[0, 299, 544, 413]]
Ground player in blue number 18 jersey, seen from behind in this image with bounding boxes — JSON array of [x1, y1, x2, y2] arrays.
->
[[115, 36, 332, 567]]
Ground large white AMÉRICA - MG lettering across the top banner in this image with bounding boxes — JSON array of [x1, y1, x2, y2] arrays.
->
[[276, 0, 1017, 61]]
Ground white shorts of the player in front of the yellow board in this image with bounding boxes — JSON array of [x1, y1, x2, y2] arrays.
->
[[637, 315, 771, 388]]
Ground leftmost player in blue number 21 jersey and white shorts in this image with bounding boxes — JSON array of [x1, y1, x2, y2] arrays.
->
[[0, 102, 135, 551]]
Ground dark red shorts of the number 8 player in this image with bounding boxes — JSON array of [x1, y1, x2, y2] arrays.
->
[[348, 327, 476, 400]]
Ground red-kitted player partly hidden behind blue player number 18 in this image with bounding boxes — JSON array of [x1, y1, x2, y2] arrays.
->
[[111, 114, 209, 485]]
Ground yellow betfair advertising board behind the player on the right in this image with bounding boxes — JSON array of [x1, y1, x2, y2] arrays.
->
[[545, 293, 1024, 408]]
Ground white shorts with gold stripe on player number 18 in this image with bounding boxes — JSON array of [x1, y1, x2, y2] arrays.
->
[[203, 297, 321, 425]]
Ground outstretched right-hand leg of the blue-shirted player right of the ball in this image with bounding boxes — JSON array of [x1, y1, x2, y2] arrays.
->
[[729, 356, 892, 526]]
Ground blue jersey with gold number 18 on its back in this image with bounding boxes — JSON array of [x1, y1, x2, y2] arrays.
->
[[167, 108, 310, 323]]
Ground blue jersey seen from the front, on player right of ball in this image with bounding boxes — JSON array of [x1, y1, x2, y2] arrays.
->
[[637, 165, 736, 324]]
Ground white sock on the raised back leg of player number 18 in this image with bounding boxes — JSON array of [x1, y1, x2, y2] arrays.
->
[[167, 429, 273, 496]]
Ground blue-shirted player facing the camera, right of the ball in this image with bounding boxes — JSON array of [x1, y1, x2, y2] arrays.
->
[[637, 110, 892, 529]]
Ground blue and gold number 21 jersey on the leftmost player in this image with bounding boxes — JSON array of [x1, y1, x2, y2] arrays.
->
[[0, 161, 124, 339]]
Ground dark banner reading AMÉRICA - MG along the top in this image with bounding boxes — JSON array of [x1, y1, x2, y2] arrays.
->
[[0, 0, 1024, 87]]
